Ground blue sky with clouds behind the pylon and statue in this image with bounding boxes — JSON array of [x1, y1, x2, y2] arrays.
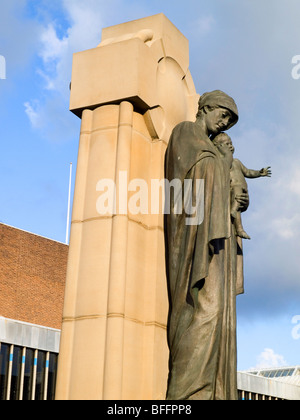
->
[[0, 0, 300, 370]]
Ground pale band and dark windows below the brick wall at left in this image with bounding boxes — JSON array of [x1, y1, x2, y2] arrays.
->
[[0, 317, 60, 400]]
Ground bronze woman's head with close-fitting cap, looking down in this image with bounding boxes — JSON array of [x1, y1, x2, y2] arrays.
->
[[196, 90, 239, 135]]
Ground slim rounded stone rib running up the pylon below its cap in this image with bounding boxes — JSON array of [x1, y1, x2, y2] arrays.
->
[[103, 102, 133, 400]]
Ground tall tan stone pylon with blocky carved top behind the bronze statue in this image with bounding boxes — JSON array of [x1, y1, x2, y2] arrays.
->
[[56, 14, 198, 400]]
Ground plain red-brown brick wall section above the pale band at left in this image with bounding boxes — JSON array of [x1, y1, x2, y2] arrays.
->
[[0, 224, 69, 329]]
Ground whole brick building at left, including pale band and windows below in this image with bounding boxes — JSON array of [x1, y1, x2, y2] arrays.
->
[[0, 224, 69, 400]]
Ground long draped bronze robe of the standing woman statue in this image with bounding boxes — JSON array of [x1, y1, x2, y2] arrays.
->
[[165, 122, 243, 400]]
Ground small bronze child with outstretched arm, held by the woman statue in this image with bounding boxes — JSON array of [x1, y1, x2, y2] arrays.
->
[[212, 133, 271, 239]]
